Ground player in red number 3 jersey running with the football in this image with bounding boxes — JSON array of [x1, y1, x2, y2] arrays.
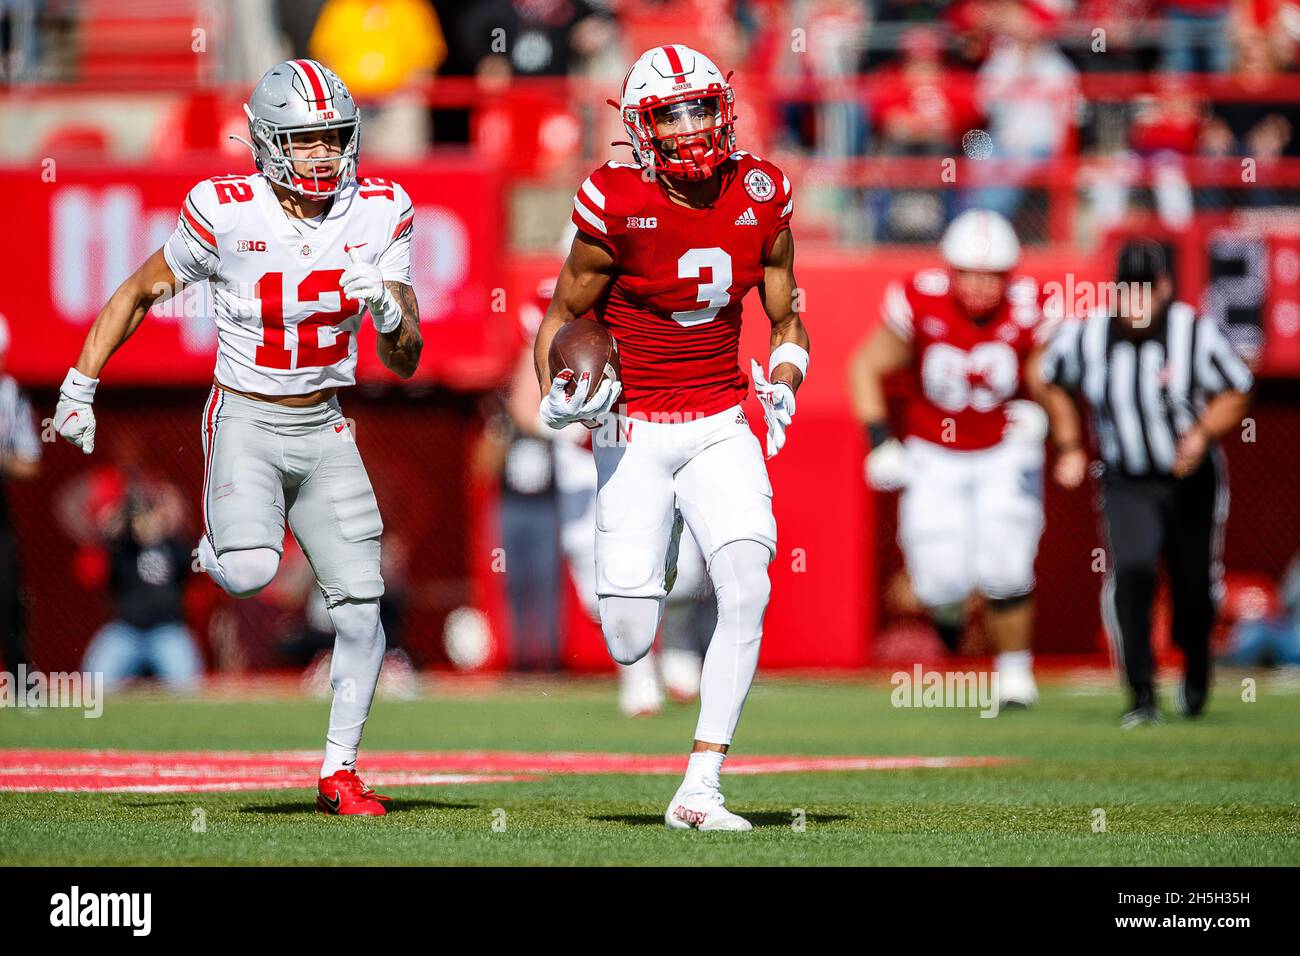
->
[[534, 44, 809, 830]]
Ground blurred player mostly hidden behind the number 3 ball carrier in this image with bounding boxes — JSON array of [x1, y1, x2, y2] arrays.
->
[[508, 270, 718, 717]]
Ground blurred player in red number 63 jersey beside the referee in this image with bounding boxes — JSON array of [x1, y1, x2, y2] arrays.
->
[[853, 209, 1052, 706]]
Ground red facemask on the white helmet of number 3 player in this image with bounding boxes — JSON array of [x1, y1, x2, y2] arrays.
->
[[624, 87, 736, 181]]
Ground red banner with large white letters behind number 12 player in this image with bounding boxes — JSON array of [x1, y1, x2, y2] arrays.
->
[[0, 160, 506, 388]]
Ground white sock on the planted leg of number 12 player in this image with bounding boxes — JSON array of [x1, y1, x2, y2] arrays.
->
[[321, 601, 385, 778]]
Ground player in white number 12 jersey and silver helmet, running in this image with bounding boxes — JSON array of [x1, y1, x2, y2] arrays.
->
[[56, 60, 423, 817]]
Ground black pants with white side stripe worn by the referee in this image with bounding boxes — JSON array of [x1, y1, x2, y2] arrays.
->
[[1101, 449, 1227, 702]]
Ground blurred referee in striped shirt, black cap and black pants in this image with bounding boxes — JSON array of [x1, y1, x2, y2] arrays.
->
[[1041, 239, 1253, 727]]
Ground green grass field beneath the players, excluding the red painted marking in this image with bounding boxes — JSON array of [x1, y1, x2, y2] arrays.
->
[[0, 675, 1300, 865]]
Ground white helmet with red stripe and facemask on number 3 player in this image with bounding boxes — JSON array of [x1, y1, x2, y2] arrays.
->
[[610, 43, 736, 179]]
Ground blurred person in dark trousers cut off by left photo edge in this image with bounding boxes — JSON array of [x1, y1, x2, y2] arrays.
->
[[0, 315, 40, 672]]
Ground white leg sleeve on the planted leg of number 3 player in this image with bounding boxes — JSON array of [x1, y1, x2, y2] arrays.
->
[[696, 541, 771, 744]]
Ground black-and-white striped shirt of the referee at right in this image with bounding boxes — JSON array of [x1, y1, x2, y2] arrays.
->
[[1043, 302, 1253, 476]]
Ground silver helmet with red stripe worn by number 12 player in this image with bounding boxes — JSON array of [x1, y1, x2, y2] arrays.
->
[[244, 60, 361, 198]]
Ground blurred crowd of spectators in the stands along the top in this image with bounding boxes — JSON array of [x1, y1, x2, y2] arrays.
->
[[0, 0, 1300, 242]]
